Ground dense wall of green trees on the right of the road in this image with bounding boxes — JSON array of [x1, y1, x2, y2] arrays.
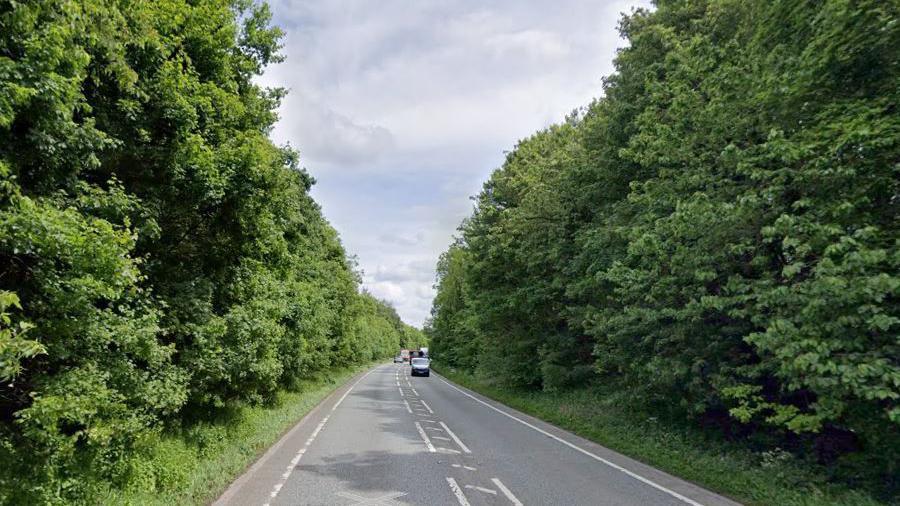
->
[[427, 0, 900, 487]]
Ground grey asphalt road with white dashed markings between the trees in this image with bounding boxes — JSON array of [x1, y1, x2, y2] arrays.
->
[[215, 365, 737, 506]]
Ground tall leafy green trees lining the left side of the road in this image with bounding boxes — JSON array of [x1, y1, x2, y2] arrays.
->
[[0, 0, 424, 504]]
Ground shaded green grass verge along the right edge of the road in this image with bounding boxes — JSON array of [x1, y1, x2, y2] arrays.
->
[[435, 364, 896, 506]]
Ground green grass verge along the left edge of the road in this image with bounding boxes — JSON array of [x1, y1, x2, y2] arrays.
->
[[96, 366, 370, 505]]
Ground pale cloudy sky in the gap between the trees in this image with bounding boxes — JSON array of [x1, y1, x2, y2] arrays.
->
[[261, 0, 648, 326]]
